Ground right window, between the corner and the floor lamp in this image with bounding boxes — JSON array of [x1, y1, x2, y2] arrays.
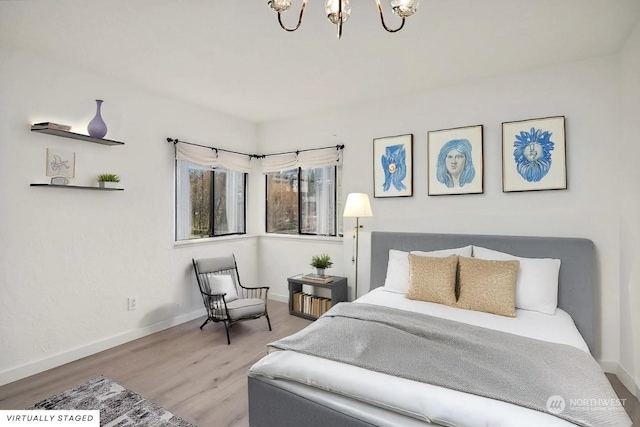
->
[[266, 166, 339, 236]]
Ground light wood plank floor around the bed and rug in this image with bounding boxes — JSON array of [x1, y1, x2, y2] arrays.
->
[[0, 301, 640, 427]]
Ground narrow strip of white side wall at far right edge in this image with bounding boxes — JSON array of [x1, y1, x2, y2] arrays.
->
[[613, 20, 640, 397]]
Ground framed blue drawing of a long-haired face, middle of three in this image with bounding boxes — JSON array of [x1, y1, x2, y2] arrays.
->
[[427, 125, 484, 196]]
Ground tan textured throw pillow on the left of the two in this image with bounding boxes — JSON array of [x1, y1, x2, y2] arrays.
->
[[404, 254, 458, 305]]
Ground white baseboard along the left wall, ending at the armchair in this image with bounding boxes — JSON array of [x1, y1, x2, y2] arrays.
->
[[0, 308, 207, 386]]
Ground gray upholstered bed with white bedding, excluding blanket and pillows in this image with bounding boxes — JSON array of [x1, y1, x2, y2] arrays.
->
[[248, 232, 630, 427]]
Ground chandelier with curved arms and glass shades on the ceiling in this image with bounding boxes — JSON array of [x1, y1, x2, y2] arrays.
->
[[268, 0, 419, 39]]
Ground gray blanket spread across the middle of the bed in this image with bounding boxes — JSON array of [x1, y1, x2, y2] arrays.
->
[[270, 303, 631, 427]]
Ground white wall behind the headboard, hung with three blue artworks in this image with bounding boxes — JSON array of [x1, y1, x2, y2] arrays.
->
[[259, 53, 638, 388]]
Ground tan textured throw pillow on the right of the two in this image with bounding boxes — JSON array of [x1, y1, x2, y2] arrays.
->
[[455, 257, 520, 317]]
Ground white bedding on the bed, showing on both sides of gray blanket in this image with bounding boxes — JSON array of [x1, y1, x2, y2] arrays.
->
[[249, 288, 588, 427]]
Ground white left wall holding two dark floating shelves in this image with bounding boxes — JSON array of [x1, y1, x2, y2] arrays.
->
[[0, 50, 257, 384]]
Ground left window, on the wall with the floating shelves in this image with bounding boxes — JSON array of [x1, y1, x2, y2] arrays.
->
[[176, 160, 247, 240]]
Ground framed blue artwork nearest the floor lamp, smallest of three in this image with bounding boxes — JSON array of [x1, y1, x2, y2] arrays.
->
[[373, 134, 413, 197]]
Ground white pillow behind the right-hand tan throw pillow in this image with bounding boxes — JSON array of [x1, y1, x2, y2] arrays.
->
[[473, 246, 560, 314]]
